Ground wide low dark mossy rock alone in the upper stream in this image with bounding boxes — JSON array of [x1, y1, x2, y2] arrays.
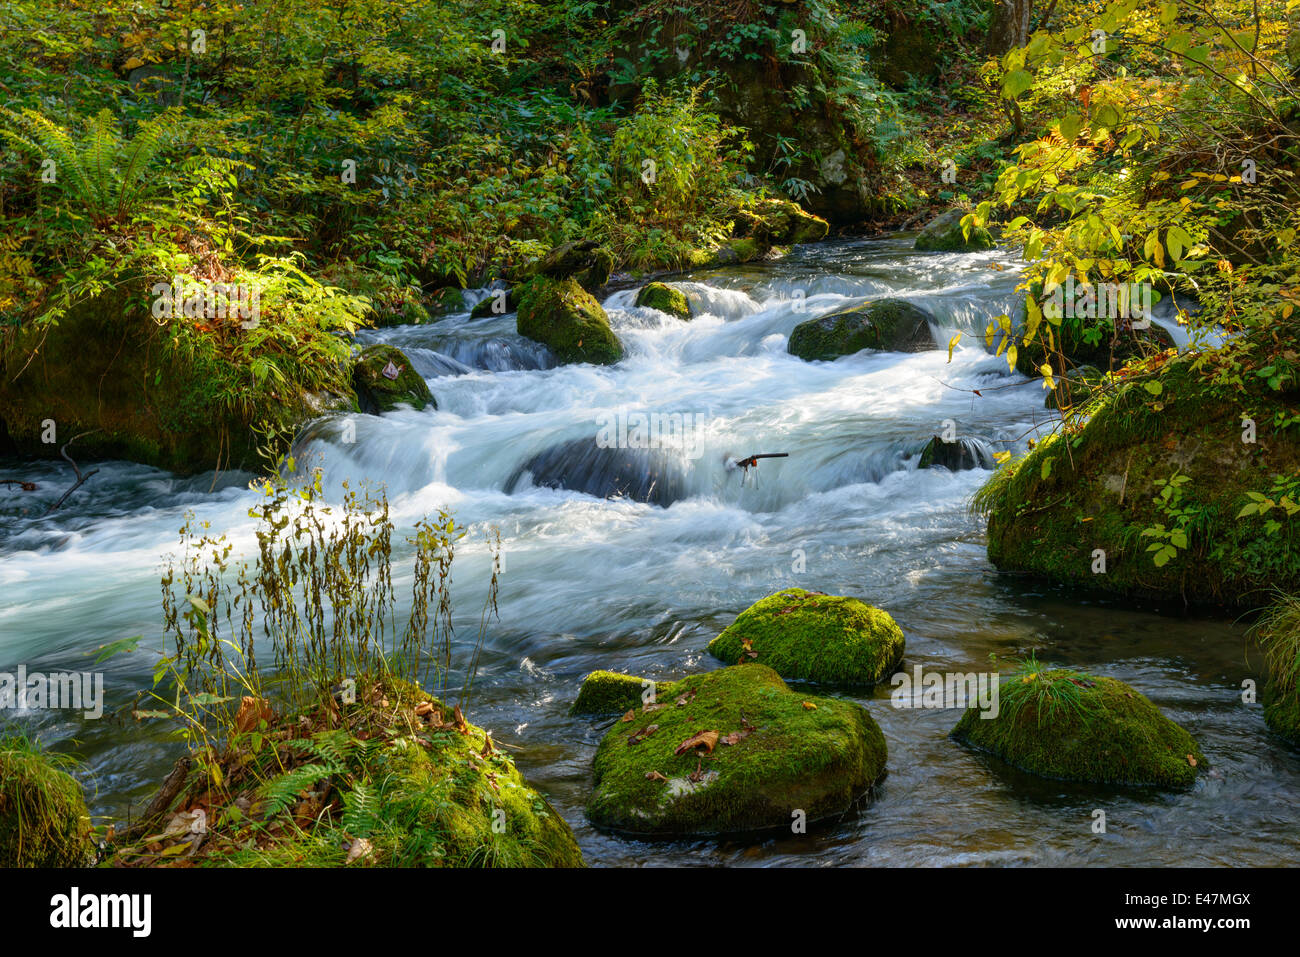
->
[[787, 299, 935, 361]]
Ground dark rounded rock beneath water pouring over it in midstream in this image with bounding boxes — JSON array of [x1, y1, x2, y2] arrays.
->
[[506, 438, 686, 507]]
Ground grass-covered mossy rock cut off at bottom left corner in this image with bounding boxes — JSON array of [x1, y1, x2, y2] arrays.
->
[[0, 737, 91, 867]]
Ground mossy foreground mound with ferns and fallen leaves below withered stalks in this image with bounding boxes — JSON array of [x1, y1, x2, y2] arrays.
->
[[113, 675, 582, 867]]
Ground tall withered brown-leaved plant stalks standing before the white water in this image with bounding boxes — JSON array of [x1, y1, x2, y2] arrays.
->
[[149, 459, 501, 741]]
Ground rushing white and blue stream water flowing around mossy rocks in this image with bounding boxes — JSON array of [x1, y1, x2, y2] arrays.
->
[[0, 238, 1300, 865]]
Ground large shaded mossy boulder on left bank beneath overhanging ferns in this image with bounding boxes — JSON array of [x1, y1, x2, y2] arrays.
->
[[0, 289, 355, 473]]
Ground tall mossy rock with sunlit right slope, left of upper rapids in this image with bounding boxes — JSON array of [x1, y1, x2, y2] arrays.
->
[[515, 276, 623, 365]]
